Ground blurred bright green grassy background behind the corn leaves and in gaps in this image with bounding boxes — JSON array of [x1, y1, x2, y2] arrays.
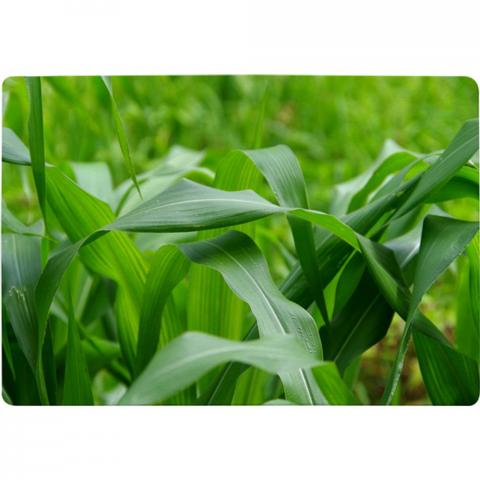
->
[[2, 76, 478, 403]]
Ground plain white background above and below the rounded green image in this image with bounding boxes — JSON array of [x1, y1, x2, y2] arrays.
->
[[0, 0, 480, 480]]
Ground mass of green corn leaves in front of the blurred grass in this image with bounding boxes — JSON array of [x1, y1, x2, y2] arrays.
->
[[2, 78, 480, 405]]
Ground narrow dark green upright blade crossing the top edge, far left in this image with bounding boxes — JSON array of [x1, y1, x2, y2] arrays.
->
[[26, 77, 46, 225]]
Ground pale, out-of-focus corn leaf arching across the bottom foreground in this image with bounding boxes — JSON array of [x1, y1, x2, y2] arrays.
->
[[120, 332, 320, 405]]
